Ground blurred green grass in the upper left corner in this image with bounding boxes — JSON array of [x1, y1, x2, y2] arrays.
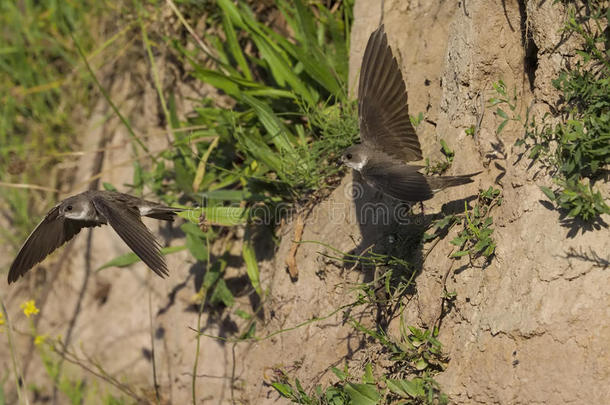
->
[[0, 0, 105, 246]]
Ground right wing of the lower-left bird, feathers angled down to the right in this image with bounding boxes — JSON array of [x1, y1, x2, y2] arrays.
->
[[91, 196, 169, 277]]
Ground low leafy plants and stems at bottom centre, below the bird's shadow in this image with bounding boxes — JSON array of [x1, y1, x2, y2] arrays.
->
[[270, 236, 448, 405]]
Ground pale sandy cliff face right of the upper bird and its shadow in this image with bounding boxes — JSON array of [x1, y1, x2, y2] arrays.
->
[[351, 1, 610, 404]]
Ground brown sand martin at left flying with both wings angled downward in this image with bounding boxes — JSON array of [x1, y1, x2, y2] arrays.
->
[[8, 191, 182, 284]]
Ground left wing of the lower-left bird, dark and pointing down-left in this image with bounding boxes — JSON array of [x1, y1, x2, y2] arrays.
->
[[8, 205, 88, 284]]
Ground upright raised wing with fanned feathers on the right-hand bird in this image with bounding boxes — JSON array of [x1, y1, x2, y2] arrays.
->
[[358, 25, 422, 161]]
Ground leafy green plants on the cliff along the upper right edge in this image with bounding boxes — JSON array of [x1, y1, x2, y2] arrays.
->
[[492, 2, 610, 222]]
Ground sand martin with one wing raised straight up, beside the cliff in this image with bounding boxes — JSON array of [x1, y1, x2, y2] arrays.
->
[[341, 25, 480, 201]]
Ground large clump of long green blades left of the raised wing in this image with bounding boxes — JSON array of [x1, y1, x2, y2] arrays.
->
[[150, 0, 358, 208]]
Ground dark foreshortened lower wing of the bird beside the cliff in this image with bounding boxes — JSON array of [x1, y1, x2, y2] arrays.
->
[[360, 159, 433, 201]]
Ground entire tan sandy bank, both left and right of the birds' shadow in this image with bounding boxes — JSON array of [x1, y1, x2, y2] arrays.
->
[[2, 0, 610, 404]]
